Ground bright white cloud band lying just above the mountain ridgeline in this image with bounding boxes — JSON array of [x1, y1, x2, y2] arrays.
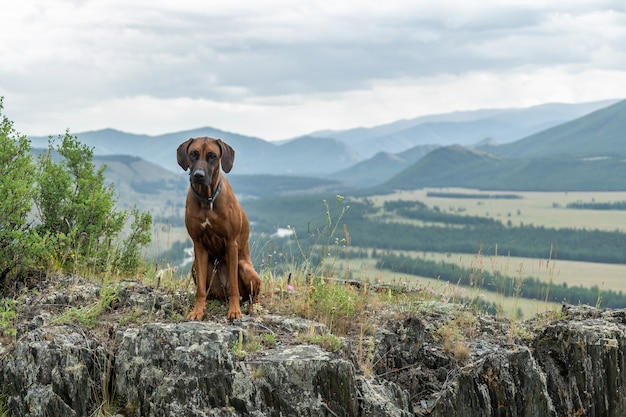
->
[[16, 68, 626, 140]]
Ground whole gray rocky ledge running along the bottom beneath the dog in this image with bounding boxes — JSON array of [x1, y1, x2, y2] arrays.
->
[[0, 278, 626, 417]]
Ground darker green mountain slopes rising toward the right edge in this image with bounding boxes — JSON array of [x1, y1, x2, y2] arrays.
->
[[379, 100, 626, 191]]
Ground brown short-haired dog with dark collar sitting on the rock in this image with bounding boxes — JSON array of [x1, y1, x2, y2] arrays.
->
[[177, 137, 261, 320]]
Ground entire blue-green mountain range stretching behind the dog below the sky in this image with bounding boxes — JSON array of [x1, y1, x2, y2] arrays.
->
[[29, 100, 626, 208]]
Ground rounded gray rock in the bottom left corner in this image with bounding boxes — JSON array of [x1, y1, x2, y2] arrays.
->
[[0, 326, 111, 417]]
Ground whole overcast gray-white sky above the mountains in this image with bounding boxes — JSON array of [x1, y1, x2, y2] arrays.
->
[[0, 0, 626, 140]]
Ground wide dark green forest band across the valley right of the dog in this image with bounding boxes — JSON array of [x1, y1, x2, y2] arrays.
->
[[243, 192, 626, 263]]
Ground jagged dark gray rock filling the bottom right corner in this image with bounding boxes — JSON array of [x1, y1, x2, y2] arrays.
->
[[422, 306, 626, 417]]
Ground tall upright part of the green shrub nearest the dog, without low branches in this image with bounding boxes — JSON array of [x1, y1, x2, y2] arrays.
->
[[35, 132, 127, 270]]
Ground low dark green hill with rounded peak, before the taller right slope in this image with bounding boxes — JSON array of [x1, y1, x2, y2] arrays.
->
[[378, 145, 626, 193]]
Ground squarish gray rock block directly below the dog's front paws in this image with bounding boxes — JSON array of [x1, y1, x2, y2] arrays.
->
[[115, 322, 243, 416]]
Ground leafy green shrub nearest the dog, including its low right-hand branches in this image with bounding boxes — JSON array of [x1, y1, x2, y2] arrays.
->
[[35, 132, 152, 273]]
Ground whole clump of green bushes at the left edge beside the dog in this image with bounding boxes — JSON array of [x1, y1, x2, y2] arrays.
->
[[0, 99, 152, 293]]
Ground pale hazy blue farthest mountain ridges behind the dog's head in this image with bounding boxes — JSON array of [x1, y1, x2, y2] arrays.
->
[[29, 100, 616, 176]]
